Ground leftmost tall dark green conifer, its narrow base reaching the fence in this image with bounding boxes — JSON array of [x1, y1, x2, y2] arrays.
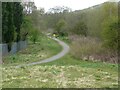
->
[[2, 2, 15, 51]]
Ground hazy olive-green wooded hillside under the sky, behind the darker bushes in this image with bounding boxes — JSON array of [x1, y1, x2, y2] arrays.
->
[[43, 2, 118, 38]]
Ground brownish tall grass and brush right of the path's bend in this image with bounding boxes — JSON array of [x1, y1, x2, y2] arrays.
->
[[69, 36, 117, 63]]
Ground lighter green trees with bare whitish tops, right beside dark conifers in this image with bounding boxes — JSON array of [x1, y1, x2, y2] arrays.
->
[[21, 2, 44, 43]]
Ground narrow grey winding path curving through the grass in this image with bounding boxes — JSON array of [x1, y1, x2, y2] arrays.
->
[[16, 37, 70, 68]]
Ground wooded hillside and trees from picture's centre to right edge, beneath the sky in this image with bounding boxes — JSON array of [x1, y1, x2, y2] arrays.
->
[[41, 2, 118, 51]]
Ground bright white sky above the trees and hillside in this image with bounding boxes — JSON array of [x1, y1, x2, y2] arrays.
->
[[34, 0, 109, 11]]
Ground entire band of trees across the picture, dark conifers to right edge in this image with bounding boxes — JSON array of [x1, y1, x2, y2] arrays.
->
[[2, 2, 118, 54]]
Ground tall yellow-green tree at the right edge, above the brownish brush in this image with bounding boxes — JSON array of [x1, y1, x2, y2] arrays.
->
[[101, 2, 119, 51]]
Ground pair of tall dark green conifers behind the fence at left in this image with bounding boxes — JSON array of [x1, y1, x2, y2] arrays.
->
[[2, 2, 23, 51]]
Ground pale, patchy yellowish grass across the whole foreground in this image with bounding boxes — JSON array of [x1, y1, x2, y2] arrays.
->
[[2, 60, 118, 88]]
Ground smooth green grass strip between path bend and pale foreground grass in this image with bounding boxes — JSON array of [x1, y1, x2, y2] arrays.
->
[[41, 54, 118, 71]]
